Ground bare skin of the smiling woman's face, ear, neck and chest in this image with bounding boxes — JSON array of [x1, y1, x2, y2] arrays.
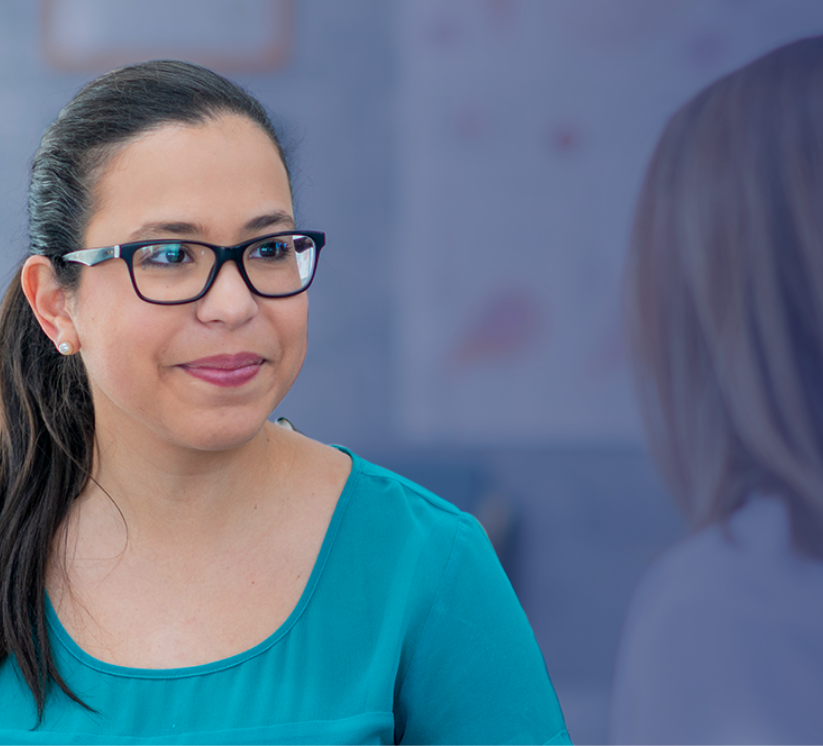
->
[[22, 115, 350, 668]]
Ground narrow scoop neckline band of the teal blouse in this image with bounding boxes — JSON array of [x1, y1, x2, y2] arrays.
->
[[45, 445, 362, 679]]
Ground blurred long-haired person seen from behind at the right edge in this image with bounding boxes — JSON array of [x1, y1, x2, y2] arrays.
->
[[612, 38, 823, 746]]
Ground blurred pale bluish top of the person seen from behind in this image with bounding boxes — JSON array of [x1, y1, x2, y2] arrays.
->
[[612, 496, 823, 746]]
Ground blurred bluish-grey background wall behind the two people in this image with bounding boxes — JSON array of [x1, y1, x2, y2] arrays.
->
[[0, 0, 823, 746]]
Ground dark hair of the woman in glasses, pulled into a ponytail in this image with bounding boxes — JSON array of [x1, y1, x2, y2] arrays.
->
[[0, 60, 291, 718]]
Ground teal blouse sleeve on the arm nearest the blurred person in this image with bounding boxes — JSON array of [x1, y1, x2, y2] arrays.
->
[[395, 517, 571, 746]]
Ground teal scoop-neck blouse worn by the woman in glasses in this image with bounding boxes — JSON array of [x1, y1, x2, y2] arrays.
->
[[0, 451, 571, 746]]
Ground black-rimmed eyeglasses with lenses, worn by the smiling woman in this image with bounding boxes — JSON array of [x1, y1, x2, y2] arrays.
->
[[62, 231, 326, 306]]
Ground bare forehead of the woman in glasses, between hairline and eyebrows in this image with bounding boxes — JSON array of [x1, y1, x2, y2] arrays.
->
[[85, 114, 292, 246]]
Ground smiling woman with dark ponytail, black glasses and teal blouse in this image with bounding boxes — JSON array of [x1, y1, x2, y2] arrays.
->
[[0, 62, 569, 746]]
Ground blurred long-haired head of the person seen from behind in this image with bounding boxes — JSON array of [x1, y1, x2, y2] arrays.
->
[[627, 37, 823, 553]]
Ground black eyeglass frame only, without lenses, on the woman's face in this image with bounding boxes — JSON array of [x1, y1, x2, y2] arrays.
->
[[59, 231, 326, 306]]
